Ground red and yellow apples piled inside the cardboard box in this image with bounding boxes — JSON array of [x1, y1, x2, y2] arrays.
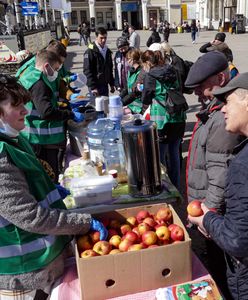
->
[[77, 207, 184, 258]]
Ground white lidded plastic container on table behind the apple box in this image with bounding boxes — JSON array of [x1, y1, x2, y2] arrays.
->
[[70, 175, 114, 207]]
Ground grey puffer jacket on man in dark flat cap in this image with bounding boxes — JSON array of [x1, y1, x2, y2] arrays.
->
[[186, 99, 240, 213]]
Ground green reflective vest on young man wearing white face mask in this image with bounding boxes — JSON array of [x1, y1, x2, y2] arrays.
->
[[18, 64, 65, 145]]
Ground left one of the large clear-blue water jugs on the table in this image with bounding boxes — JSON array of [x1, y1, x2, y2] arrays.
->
[[87, 118, 114, 163]]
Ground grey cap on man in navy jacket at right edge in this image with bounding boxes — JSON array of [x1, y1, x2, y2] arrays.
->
[[213, 72, 248, 101]]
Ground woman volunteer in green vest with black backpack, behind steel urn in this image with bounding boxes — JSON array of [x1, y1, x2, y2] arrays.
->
[[141, 50, 186, 189]]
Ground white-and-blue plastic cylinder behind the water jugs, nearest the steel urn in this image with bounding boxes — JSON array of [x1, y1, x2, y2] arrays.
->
[[109, 96, 123, 129]]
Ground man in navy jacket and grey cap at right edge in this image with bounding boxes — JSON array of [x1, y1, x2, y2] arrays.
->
[[189, 73, 248, 300]]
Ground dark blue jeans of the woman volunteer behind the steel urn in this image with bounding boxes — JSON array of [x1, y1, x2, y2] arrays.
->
[[159, 138, 182, 190]]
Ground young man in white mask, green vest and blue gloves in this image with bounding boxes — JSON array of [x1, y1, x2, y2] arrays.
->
[[18, 50, 84, 182]]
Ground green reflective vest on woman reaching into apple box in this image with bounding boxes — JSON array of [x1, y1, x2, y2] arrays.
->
[[0, 134, 71, 275]]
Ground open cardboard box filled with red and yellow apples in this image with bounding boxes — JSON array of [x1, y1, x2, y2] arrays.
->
[[76, 204, 192, 300]]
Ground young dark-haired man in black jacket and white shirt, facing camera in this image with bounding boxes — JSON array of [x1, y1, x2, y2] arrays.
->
[[84, 27, 115, 96]]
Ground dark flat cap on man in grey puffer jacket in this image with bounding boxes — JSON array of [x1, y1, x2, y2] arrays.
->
[[185, 51, 228, 88]]
